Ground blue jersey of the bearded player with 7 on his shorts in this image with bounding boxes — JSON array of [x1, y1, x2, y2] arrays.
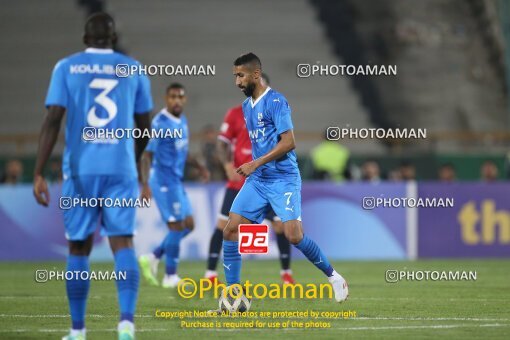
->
[[243, 87, 300, 180]]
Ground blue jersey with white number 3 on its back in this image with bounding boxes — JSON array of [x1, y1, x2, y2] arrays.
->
[[46, 48, 153, 178]]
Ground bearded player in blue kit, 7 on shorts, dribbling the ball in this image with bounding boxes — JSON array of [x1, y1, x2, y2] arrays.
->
[[218, 53, 349, 302]]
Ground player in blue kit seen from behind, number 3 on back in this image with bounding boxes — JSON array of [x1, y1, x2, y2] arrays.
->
[[34, 13, 153, 340]]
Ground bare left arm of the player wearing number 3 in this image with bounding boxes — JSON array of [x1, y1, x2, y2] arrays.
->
[[34, 105, 66, 207]]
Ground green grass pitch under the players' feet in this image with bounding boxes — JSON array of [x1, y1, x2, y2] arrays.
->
[[0, 260, 510, 339]]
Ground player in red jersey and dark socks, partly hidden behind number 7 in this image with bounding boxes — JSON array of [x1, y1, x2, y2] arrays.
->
[[205, 74, 294, 283]]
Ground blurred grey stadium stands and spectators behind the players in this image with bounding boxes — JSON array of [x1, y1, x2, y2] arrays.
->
[[0, 0, 510, 184]]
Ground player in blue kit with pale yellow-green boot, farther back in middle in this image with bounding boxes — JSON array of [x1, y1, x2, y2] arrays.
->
[[138, 83, 209, 288]]
